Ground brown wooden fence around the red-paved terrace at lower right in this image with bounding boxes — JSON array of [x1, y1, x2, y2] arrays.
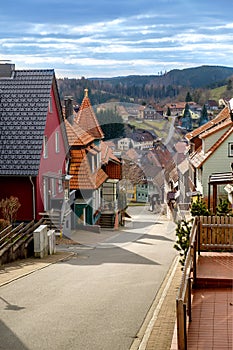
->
[[176, 216, 233, 350]]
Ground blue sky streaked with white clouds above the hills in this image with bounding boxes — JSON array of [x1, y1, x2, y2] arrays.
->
[[0, 0, 233, 78]]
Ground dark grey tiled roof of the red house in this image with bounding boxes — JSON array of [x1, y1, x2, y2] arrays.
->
[[0, 70, 54, 176]]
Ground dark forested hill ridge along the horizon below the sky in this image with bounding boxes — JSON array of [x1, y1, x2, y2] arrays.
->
[[58, 66, 233, 104]]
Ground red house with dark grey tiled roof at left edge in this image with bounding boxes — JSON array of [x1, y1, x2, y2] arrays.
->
[[0, 64, 68, 221]]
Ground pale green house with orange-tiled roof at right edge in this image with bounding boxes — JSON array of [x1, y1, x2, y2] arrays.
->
[[186, 107, 233, 208]]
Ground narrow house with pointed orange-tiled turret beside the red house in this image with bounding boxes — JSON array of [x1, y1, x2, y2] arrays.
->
[[65, 89, 121, 228]]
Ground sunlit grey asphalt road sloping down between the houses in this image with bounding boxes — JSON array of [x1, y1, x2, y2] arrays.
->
[[0, 207, 176, 350]]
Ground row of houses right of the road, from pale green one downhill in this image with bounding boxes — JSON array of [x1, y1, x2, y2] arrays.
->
[[106, 99, 233, 216]]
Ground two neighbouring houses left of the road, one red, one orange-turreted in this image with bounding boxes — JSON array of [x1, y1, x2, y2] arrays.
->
[[0, 64, 124, 232]]
